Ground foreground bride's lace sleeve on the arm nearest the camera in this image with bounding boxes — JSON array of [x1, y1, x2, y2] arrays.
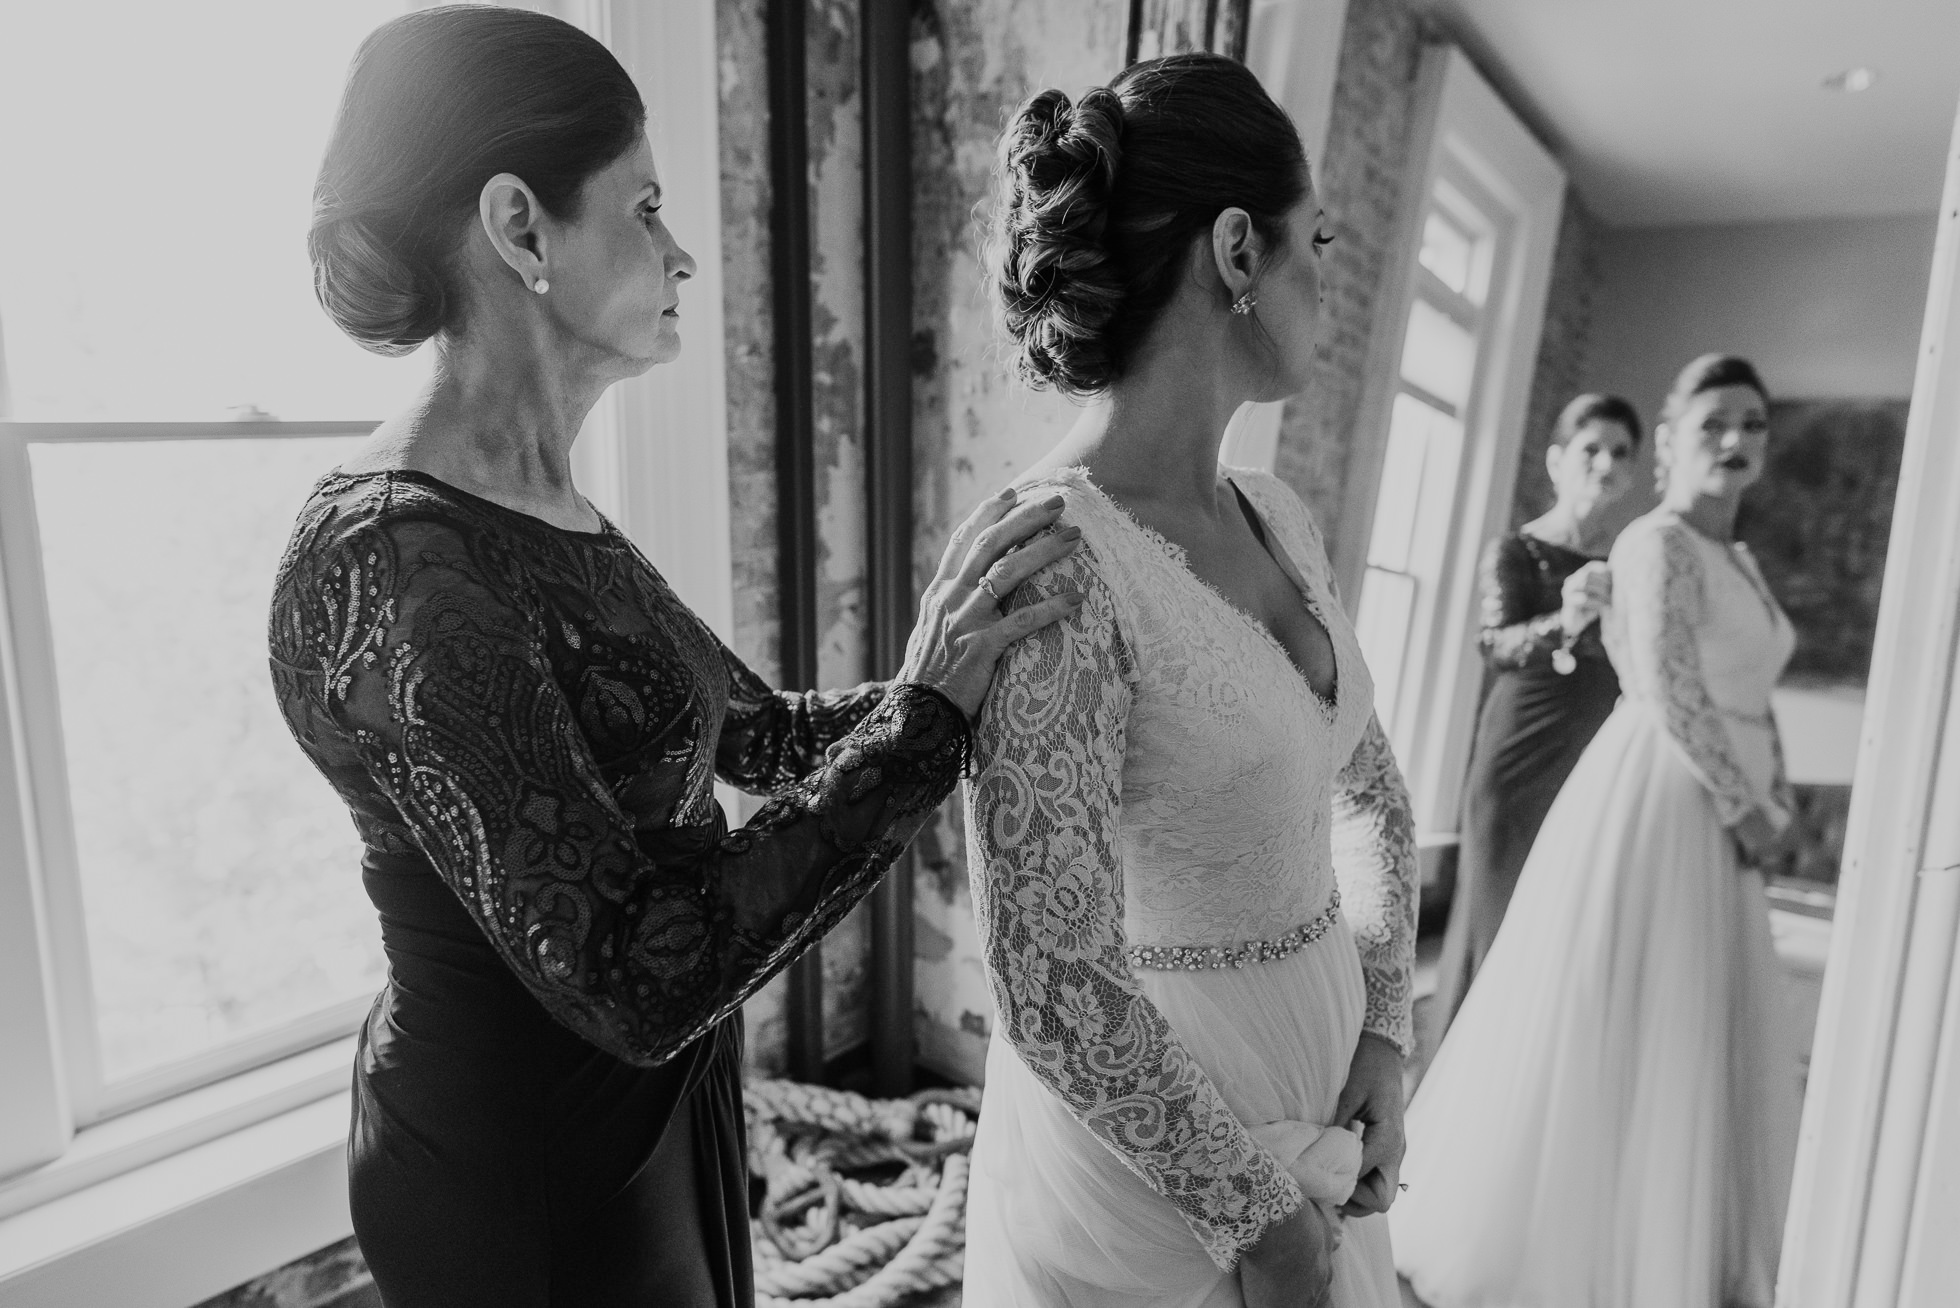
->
[[966, 547, 1303, 1271]]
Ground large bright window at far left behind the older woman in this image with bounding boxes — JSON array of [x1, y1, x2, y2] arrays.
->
[[0, 0, 429, 1184]]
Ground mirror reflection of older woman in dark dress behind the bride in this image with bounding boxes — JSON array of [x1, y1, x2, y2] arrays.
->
[[1433, 394, 1641, 1039]]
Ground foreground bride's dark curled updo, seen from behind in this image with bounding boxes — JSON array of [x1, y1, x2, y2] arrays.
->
[[988, 55, 1309, 396]]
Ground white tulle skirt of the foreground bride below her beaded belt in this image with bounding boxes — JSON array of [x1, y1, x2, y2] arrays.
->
[[964, 920, 1401, 1308]]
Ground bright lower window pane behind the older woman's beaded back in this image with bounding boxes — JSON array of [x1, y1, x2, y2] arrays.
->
[[29, 437, 380, 1081]]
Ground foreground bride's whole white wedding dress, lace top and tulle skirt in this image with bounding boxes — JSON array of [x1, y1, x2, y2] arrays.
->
[[964, 469, 1415, 1308]]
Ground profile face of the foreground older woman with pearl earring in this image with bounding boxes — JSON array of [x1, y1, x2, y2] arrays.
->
[[547, 135, 694, 377]]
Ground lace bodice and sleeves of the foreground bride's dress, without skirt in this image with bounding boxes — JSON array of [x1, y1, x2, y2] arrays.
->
[[966, 471, 1415, 1269]]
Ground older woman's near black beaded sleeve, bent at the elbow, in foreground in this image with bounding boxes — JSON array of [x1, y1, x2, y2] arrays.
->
[[301, 520, 968, 1067]]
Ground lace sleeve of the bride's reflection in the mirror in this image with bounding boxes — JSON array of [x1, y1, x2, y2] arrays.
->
[[1613, 524, 1776, 826]]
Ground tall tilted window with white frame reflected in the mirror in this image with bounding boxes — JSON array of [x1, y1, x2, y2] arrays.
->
[[1341, 47, 1564, 843]]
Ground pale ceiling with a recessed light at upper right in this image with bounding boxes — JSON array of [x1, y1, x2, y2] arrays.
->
[[1415, 0, 1960, 227]]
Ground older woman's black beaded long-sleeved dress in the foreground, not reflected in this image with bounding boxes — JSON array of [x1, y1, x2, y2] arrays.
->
[[270, 471, 970, 1308]]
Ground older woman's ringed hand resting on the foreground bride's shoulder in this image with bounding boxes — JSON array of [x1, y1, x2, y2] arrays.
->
[[898, 486, 1084, 720]]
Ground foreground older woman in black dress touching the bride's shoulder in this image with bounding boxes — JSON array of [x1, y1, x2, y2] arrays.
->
[[270, 6, 1076, 1308]]
